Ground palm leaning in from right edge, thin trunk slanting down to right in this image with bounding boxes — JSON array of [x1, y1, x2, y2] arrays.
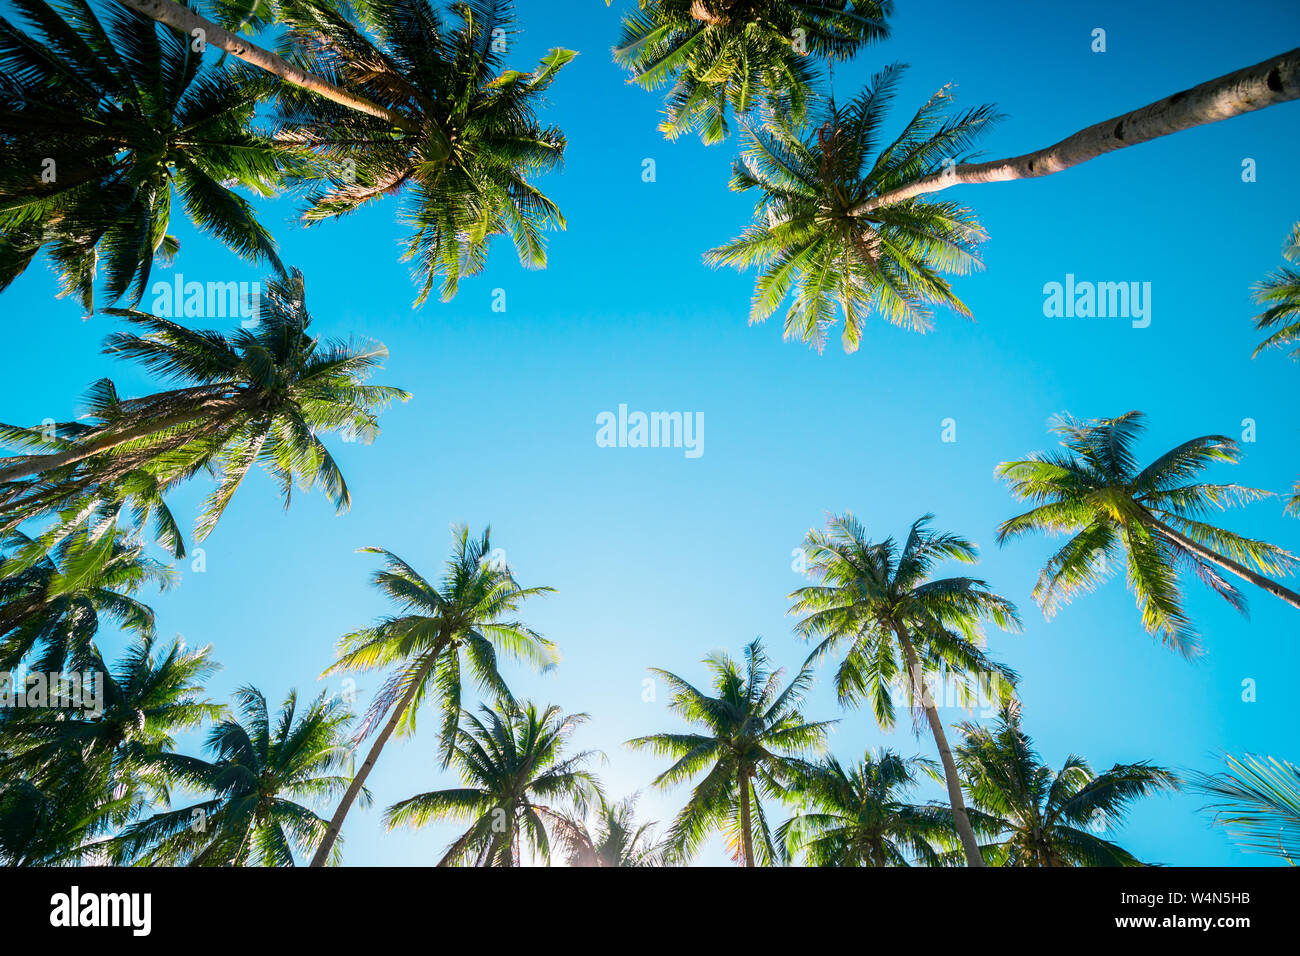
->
[[997, 411, 1300, 656]]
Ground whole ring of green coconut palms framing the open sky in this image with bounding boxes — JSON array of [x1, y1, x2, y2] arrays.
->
[[0, 0, 1300, 866]]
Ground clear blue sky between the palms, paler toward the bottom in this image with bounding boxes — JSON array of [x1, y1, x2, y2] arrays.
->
[[0, 0, 1300, 865]]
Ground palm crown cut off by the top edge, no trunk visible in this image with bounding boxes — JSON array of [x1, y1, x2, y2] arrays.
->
[[606, 0, 893, 143]]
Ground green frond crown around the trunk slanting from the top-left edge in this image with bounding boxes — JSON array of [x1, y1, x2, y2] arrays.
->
[[280, 0, 575, 303]]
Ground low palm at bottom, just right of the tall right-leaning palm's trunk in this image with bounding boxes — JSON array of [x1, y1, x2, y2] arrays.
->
[[384, 701, 599, 866]]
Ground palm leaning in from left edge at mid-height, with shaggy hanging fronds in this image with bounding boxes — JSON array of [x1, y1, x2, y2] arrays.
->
[[0, 271, 410, 538]]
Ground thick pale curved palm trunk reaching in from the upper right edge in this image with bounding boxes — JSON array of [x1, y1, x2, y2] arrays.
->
[[852, 48, 1300, 216]]
